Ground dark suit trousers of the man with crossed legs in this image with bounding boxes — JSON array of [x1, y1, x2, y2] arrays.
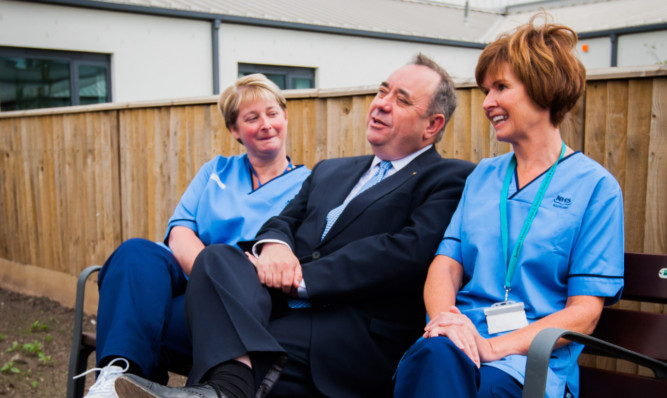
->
[[185, 245, 319, 397]]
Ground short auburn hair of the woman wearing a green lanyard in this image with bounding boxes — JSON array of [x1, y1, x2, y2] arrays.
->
[[475, 13, 586, 126]]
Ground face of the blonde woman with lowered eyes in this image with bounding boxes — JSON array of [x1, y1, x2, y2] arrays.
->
[[230, 99, 287, 159]]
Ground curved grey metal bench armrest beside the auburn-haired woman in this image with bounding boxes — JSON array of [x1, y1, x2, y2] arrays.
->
[[522, 328, 667, 398]]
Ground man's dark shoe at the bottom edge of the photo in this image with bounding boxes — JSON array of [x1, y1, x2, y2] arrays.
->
[[114, 374, 227, 398]]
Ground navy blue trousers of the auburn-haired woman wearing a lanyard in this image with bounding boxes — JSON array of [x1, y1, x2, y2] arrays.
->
[[394, 336, 523, 398]]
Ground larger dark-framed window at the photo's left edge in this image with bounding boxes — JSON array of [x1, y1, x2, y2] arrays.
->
[[0, 47, 111, 111]]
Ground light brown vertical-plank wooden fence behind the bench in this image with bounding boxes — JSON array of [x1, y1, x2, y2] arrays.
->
[[0, 66, 667, 376]]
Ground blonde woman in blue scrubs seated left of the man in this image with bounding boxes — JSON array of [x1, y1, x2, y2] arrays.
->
[[77, 74, 310, 398]]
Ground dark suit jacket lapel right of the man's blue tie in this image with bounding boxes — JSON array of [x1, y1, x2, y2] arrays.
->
[[321, 147, 440, 243]]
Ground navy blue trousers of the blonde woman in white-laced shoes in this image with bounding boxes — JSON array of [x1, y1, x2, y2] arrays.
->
[[97, 238, 192, 382]]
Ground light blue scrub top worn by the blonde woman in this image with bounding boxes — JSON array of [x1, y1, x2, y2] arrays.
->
[[164, 154, 310, 246]]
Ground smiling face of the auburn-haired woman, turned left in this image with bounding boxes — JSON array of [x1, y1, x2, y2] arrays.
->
[[482, 63, 551, 144]]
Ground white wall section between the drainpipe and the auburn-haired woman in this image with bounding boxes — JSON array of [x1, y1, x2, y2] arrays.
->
[[220, 24, 481, 88]]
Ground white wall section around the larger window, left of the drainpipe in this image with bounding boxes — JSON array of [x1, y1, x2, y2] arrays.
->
[[0, 1, 213, 102]]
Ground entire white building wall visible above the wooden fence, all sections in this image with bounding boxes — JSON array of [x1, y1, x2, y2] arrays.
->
[[0, 0, 667, 101]]
